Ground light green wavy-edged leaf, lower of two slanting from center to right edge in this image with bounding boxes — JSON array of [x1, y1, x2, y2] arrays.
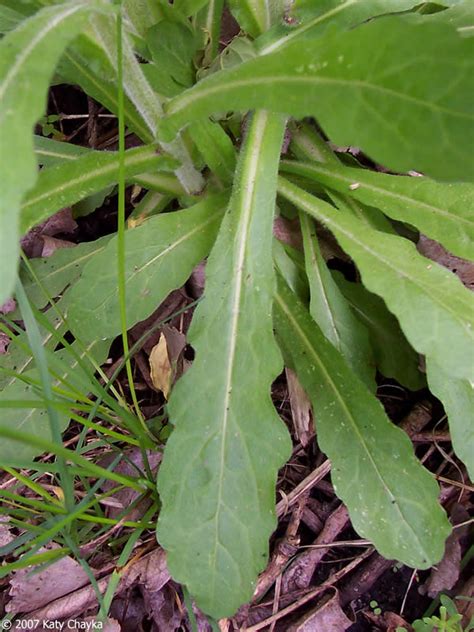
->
[[279, 178, 474, 381]]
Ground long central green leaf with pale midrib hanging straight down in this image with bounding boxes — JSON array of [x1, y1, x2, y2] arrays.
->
[[158, 112, 290, 619]]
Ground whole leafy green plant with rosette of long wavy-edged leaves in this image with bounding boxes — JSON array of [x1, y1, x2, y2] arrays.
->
[[0, 0, 474, 618]]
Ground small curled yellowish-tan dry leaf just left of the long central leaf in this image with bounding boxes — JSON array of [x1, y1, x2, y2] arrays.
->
[[149, 326, 186, 399]]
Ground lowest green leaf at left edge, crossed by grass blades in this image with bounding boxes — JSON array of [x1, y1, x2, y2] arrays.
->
[[0, 340, 110, 466]]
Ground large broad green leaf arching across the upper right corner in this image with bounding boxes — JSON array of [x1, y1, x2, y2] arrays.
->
[[161, 17, 474, 180]]
